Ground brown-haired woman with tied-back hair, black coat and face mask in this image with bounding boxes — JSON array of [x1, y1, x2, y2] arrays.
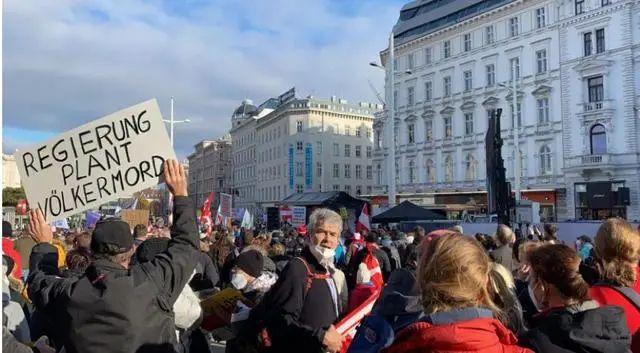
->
[[522, 244, 631, 353]]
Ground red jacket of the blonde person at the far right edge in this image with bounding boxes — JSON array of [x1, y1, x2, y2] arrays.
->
[[589, 268, 640, 353]]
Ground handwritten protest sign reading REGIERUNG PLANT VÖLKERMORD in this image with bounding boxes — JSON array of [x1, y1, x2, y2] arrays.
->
[[16, 99, 176, 221]]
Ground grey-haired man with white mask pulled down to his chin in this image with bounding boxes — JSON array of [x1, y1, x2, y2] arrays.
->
[[248, 208, 342, 353]]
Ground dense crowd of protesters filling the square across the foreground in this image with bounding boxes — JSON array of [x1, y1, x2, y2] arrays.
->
[[2, 161, 640, 353]]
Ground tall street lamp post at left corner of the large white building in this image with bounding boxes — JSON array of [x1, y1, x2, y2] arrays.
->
[[369, 31, 412, 207]]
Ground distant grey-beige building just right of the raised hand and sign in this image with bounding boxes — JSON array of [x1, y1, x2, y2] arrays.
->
[[187, 135, 232, 207]]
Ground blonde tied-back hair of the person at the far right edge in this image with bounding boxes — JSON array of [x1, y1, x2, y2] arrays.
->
[[593, 218, 640, 287]]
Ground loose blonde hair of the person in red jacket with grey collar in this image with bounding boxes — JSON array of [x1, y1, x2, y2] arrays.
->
[[418, 234, 500, 314]]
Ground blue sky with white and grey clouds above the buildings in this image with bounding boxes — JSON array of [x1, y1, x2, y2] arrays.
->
[[2, 0, 406, 157]]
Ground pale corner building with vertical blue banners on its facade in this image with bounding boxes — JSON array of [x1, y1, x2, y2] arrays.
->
[[232, 90, 381, 209]]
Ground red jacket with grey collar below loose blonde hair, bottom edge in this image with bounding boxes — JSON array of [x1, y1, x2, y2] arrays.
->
[[383, 318, 533, 353]]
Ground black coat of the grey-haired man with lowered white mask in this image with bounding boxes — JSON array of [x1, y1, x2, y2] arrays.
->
[[249, 247, 338, 353]]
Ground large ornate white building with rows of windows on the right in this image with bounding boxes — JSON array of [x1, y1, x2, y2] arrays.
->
[[374, 0, 640, 220]]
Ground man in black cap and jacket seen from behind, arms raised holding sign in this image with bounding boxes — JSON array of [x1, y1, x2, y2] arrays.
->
[[28, 160, 198, 353]]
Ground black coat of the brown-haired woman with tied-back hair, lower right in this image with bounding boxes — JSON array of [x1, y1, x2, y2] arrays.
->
[[520, 306, 631, 353]]
